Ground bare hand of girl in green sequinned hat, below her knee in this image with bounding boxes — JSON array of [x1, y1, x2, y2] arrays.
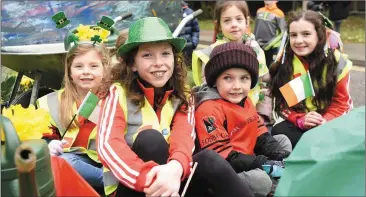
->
[[144, 160, 183, 196]]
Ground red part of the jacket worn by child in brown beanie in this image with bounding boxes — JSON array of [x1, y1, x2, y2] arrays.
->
[[195, 99, 267, 158]]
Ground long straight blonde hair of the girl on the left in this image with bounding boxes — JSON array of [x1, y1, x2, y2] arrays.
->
[[60, 44, 110, 128]]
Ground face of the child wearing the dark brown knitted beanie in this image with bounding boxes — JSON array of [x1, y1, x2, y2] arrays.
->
[[216, 68, 252, 103]]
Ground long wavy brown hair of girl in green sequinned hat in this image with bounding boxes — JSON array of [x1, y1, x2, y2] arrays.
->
[[108, 42, 190, 109]]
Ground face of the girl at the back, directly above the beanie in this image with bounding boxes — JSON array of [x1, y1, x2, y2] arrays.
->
[[220, 5, 247, 42]]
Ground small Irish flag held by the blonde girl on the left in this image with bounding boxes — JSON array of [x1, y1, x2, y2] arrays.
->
[[77, 91, 100, 124]]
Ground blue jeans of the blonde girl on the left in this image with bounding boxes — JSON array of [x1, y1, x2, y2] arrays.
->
[[59, 153, 103, 187]]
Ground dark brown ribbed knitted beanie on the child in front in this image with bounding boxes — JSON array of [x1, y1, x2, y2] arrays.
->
[[205, 42, 259, 88]]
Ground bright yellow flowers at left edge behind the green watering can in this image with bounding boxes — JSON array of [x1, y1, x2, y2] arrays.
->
[[1, 104, 52, 141]]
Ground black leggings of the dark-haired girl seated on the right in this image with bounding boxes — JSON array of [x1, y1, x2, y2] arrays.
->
[[271, 120, 305, 149]]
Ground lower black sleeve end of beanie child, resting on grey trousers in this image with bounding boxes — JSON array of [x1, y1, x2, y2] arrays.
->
[[226, 150, 267, 173]]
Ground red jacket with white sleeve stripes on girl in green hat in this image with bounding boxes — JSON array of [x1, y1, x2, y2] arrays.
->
[[97, 83, 195, 192]]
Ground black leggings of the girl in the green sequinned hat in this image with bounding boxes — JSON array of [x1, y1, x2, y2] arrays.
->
[[116, 130, 254, 197]]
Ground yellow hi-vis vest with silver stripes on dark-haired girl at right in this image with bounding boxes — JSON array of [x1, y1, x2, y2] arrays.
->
[[293, 50, 352, 111]]
